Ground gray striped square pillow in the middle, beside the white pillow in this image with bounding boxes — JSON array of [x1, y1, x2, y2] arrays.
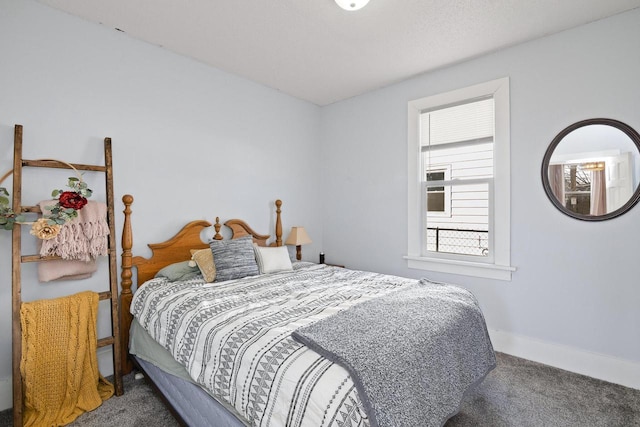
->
[[209, 236, 260, 282]]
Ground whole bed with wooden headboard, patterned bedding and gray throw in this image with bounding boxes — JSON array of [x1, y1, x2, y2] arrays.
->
[[121, 195, 495, 427]]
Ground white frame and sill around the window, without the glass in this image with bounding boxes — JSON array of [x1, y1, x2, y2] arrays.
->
[[404, 77, 515, 281]]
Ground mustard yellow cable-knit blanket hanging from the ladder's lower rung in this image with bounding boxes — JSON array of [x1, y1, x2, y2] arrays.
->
[[20, 291, 113, 427]]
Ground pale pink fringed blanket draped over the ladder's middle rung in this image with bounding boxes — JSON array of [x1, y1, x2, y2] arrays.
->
[[38, 200, 109, 282]]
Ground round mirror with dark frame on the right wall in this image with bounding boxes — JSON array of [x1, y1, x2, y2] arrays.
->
[[542, 119, 640, 221]]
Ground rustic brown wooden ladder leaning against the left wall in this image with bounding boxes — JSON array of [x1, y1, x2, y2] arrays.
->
[[12, 125, 124, 427]]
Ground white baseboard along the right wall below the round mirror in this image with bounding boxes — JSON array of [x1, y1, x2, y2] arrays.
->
[[489, 330, 640, 390]]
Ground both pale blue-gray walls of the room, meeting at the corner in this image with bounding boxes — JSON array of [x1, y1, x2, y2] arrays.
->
[[0, 0, 640, 409]]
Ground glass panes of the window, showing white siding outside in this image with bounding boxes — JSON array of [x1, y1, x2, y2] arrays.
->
[[420, 98, 494, 258]]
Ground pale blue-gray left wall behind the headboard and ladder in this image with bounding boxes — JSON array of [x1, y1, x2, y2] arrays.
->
[[0, 0, 322, 410]]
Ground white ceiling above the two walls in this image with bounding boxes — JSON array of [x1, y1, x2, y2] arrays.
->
[[38, 0, 640, 106]]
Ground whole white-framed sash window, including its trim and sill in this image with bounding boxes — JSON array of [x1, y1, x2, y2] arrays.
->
[[406, 78, 514, 280]]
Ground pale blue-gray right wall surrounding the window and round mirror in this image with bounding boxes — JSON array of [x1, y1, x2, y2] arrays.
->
[[322, 6, 640, 388]]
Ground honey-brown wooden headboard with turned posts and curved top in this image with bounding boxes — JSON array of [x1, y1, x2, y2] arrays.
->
[[120, 194, 282, 374]]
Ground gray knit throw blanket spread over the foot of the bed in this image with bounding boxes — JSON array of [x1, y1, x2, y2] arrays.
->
[[293, 279, 496, 427]]
